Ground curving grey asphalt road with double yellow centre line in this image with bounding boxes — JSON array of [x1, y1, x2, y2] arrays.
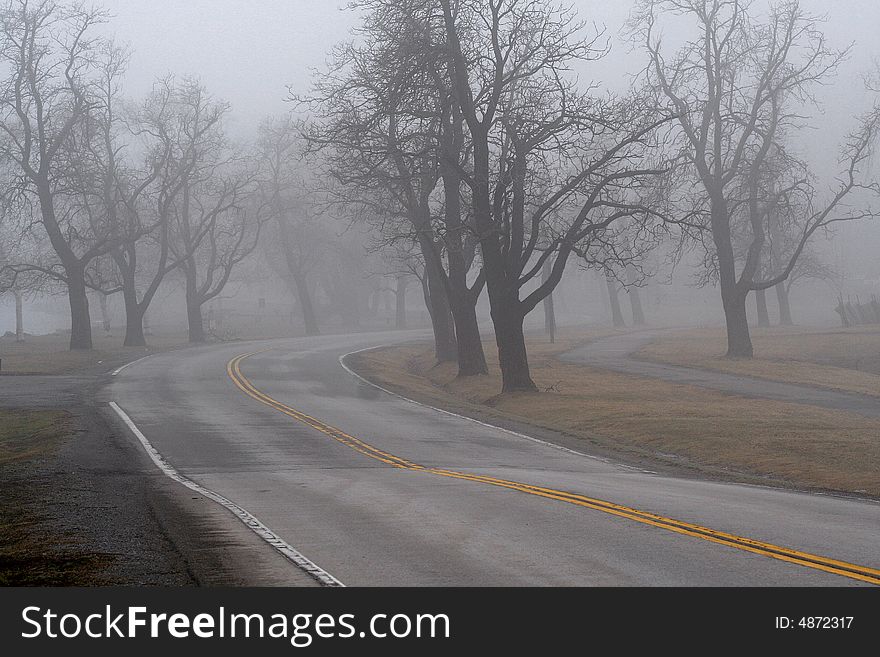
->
[[103, 333, 880, 586]]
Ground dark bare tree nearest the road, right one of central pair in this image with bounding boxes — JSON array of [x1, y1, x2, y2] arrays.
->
[[440, 0, 666, 392]]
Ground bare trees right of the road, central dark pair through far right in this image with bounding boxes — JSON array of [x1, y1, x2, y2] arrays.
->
[[298, 0, 880, 391]]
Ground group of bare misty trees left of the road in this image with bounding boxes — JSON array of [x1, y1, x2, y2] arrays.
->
[[0, 0, 296, 349]]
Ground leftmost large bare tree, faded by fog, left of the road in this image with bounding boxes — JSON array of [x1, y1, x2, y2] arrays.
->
[[0, 0, 113, 349]]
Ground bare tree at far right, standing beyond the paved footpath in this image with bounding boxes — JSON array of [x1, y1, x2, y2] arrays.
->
[[633, 0, 878, 358]]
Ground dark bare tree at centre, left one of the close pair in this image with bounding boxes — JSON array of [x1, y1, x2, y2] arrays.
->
[[305, 0, 470, 364]]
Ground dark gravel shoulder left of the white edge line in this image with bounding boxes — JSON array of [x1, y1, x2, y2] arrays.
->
[[0, 346, 315, 586]]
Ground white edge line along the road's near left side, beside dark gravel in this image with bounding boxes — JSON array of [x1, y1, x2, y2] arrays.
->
[[110, 402, 345, 586]]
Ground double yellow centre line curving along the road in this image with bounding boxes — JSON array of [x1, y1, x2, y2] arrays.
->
[[226, 352, 880, 585]]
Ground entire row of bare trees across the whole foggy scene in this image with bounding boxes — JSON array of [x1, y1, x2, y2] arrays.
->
[[0, 0, 880, 391]]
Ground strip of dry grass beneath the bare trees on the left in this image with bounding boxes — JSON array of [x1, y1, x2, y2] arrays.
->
[[0, 333, 186, 374]]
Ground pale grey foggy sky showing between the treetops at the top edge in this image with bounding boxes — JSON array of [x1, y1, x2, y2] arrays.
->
[[98, 0, 880, 142]]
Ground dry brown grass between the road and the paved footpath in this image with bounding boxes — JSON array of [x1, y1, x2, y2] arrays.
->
[[354, 326, 880, 496]]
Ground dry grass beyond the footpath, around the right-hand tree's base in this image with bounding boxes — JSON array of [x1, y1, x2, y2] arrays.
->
[[635, 326, 880, 397]]
